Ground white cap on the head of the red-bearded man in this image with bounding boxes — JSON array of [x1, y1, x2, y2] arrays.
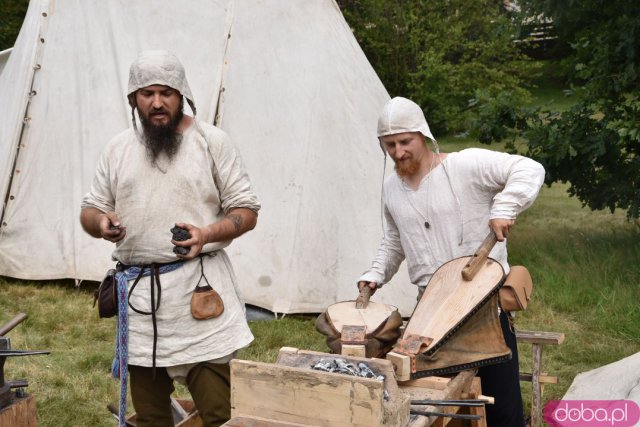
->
[[378, 96, 436, 143]]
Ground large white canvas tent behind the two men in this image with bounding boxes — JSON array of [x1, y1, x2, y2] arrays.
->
[[0, 0, 416, 315]]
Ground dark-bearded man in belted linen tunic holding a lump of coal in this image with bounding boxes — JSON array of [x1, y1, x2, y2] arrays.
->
[[80, 51, 260, 427]]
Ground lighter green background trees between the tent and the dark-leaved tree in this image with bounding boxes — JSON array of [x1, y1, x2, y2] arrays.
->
[[338, 0, 533, 134]]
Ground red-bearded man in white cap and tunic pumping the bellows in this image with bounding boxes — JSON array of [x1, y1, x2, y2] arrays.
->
[[358, 97, 544, 427]]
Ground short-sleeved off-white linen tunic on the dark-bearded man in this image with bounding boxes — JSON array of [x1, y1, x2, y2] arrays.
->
[[82, 122, 260, 367]]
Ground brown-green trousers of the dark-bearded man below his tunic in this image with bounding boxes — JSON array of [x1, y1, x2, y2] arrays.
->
[[129, 363, 231, 427]]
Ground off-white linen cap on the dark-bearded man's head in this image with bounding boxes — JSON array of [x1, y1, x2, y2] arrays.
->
[[127, 50, 196, 115]]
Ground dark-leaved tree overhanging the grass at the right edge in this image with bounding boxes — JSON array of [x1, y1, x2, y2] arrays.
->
[[477, 0, 640, 219]]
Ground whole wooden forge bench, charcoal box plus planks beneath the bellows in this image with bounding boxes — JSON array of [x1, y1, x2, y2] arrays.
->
[[225, 348, 485, 427]]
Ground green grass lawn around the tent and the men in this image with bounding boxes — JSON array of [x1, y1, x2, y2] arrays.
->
[[0, 185, 640, 427]]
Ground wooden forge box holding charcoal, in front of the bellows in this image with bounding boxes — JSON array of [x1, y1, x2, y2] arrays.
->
[[227, 348, 409, 427]]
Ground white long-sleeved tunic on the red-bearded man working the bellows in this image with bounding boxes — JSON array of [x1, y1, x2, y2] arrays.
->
[[358, 148, 544, 292]]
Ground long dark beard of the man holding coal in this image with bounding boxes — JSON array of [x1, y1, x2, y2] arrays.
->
[[140, 110, 184, 166]]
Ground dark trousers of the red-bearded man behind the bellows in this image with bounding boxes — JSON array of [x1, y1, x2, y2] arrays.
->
[[478, 312, 525, 427]]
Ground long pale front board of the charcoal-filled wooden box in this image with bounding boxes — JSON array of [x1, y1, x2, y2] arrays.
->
[[231, 355, 409, 427]]
